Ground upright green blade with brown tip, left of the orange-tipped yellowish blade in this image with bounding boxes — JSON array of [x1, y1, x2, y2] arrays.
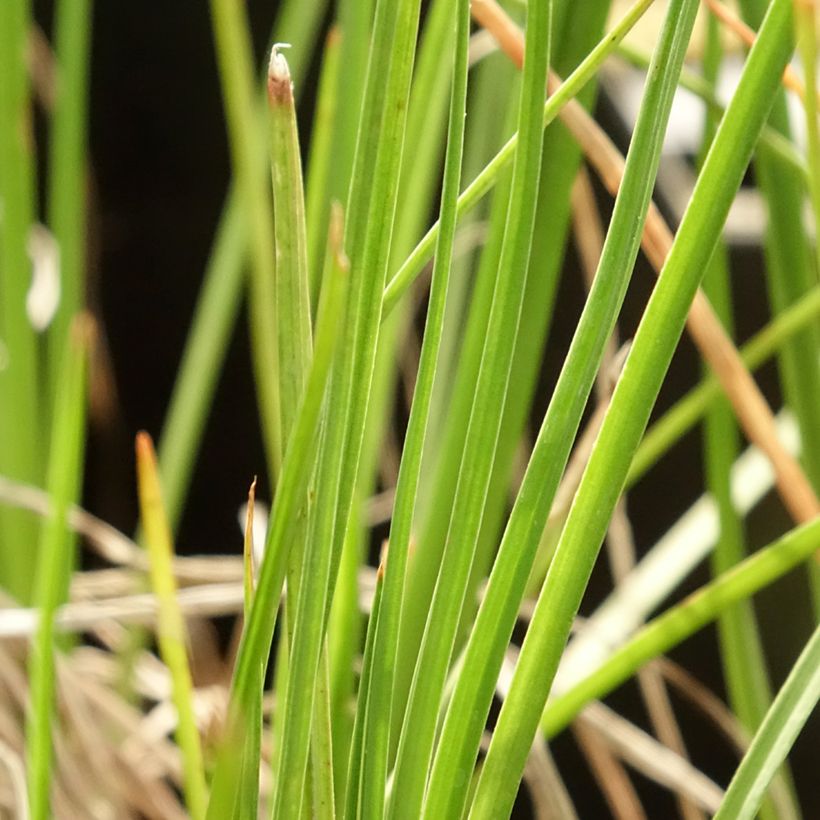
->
[[26, 322, 90, 820]]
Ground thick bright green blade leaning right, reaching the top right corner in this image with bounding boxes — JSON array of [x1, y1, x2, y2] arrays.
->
[[473, 0, 791, 817]]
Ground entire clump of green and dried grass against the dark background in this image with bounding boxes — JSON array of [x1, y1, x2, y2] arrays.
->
[[0, 0, 820, 820]]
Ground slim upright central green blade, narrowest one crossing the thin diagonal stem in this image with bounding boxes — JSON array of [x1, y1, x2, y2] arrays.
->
[[359, 2, 470, 817]]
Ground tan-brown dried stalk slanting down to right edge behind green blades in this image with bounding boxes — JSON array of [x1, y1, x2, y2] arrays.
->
[[472, 0, 820, 523]]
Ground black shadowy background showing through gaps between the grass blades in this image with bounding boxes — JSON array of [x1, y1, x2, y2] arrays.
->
[[30, 0, 820, 818]]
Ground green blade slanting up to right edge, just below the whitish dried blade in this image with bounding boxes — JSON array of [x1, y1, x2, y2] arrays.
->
[[541, 521, 820, 738]]
